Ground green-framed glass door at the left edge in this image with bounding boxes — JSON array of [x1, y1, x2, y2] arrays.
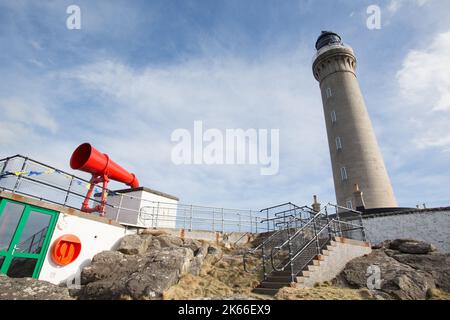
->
[[0, 199, 58, 279]]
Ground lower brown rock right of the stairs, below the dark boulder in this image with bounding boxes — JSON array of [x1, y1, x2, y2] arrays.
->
[[339, 250, 435, 300]]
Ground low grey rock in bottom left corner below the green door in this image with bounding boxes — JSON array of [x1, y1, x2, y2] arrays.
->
[[0, 276, 73, 300]]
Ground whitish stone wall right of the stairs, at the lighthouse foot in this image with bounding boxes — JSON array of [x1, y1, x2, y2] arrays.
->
[[356, 208, 450, 252]]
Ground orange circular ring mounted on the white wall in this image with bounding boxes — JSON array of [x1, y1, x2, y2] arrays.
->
[[51, 234, 81, 266]]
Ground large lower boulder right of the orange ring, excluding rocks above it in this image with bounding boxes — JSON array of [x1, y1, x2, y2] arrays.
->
[[80, 247, 194, 299]]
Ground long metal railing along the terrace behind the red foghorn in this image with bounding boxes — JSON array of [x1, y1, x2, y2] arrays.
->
[[0, 155, 262, 233]]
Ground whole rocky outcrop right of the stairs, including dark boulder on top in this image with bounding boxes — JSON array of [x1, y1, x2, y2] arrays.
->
[[336, 239, 450, 300]]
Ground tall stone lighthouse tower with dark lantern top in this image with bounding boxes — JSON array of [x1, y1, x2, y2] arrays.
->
[[313, 31, 397, 209]]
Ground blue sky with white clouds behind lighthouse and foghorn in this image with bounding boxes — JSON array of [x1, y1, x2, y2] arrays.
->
[[0, 0, 450, 209]]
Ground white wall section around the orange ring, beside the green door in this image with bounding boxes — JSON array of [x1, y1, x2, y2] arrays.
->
[[39, 213, 126, 284]]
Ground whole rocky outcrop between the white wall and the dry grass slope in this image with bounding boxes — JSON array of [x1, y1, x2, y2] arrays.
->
[[78, 233, 216, 299]]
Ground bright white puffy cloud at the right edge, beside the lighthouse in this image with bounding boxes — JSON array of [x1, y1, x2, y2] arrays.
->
[[397, 31, 450, 151]]
